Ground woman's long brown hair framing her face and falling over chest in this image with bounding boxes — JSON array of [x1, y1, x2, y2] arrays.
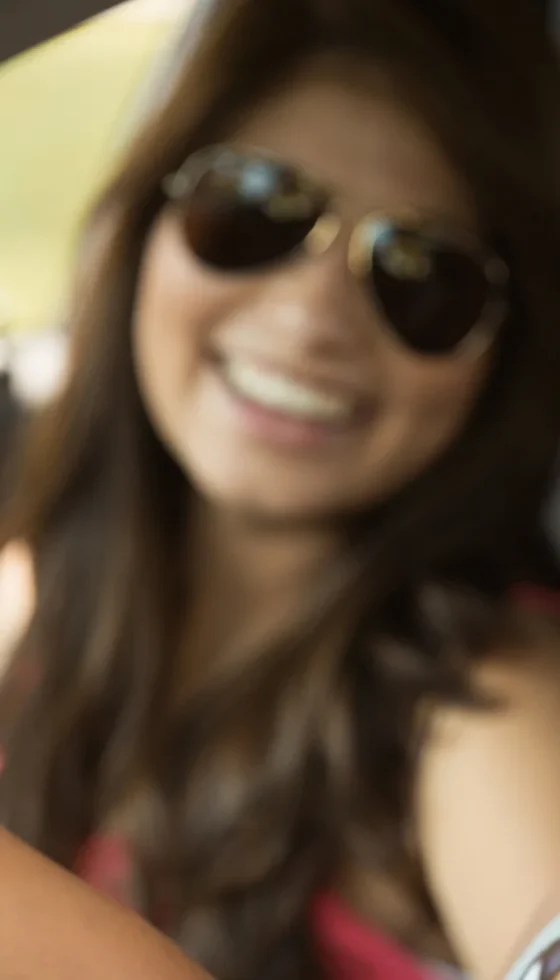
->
[[0, 0, 560, 980]]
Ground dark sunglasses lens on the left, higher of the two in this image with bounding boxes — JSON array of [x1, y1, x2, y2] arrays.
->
[[177, 153, 325, 272]]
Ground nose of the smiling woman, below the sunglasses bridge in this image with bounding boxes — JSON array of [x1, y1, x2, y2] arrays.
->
[[248, 232, 375, 360]]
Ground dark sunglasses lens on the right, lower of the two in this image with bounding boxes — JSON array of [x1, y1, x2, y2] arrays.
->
[[372, 223, 491, 355]]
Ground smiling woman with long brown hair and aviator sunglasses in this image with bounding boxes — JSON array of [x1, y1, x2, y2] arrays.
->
[[1, 0, 560, 980]]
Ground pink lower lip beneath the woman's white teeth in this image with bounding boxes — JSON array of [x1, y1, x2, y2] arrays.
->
[[217, 375, 357, 449]]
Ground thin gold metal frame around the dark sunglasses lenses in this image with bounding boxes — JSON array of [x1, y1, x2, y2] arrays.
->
[[161, 143, 510, 358]]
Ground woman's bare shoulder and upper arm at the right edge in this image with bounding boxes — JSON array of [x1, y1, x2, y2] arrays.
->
[[417, 616, 560, 980]]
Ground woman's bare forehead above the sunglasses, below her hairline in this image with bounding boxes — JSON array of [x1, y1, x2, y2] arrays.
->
[[234, 61, 476, 226]]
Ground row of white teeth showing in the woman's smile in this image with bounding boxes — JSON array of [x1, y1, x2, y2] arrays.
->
[[214, 356, 364, 428]]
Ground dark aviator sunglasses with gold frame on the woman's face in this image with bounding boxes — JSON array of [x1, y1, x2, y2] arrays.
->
[[163, 145, 509, 356]]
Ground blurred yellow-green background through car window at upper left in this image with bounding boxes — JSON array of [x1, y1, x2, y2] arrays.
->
[[0, 0, 188, 331]]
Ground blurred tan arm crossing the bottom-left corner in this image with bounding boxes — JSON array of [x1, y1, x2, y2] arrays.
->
[[0, 830, 209, 980]]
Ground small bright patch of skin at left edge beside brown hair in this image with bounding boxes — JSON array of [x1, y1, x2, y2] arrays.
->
[[0, 541, 35, 677]]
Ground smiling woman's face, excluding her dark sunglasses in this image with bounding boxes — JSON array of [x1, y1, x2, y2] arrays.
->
[[134, 58, 496, 521]]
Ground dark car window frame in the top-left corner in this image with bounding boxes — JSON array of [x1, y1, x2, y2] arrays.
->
[[0, 0, 123, 62]]
